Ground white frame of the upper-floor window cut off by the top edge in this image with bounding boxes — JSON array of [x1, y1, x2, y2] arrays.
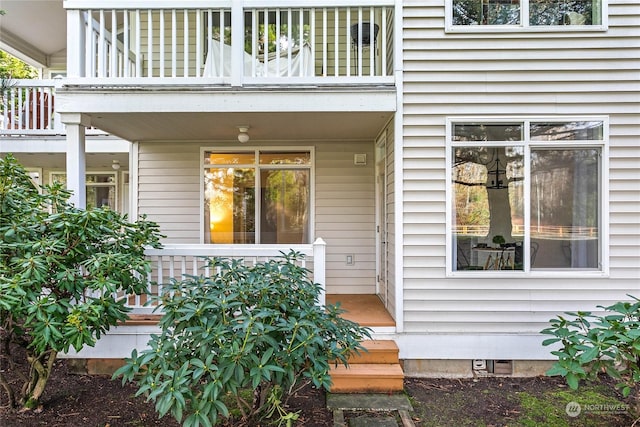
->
[[445, 0, 609, 33]]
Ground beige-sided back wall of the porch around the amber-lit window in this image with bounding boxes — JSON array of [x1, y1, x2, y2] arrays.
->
[[137, 141, 376, 294]]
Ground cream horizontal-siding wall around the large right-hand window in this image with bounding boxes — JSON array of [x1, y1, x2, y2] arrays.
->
[[399, 1, 640, 359]]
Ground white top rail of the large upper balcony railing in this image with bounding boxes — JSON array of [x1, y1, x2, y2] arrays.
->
[[64, 0, 395, 10]]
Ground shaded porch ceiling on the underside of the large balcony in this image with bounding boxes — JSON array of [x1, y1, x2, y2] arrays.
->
[[90, 112, 391, 142]]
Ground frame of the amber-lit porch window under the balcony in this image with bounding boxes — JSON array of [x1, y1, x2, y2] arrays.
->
[[198, 145, 315, 247]]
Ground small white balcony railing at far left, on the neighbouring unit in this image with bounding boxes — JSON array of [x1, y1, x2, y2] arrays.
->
[[0, 79, 62, 135]]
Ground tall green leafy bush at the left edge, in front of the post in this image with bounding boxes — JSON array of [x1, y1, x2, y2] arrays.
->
[[0, 155, 160, 408]]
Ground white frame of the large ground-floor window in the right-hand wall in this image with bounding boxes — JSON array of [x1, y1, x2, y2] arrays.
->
[[445, 116, 609, 279]]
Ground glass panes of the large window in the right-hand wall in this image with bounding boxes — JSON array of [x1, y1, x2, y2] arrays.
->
[[448, 119, 606, 274]]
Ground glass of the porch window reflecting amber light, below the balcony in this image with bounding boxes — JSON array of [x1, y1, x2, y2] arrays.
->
[[203, 150, 312, 244]]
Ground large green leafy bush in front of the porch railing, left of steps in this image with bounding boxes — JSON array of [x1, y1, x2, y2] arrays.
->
[[114, 252, 369, 426]]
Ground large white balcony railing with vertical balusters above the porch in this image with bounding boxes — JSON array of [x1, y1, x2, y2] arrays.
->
[[65, 0, 394, 86]]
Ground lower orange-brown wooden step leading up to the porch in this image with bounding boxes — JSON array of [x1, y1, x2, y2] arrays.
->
[[329, 363, 404, 393]]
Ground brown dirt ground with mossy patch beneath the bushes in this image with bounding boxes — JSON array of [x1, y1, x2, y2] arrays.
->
[[0, 360, 634, 427]]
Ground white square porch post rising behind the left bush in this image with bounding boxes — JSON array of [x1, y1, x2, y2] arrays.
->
[[61, 114, 90, 209]]
